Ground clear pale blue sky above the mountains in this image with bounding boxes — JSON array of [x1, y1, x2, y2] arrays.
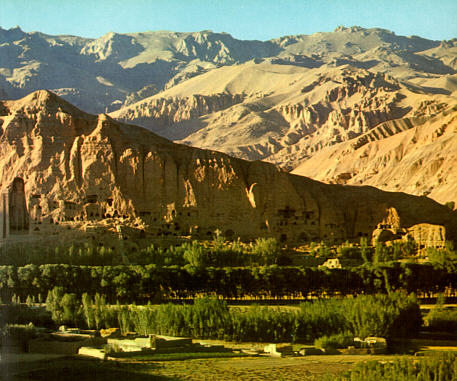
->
[[0, 0, 457, 40]]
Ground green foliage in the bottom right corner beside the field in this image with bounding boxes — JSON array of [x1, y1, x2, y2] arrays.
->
[[332, 353, 457, 381]]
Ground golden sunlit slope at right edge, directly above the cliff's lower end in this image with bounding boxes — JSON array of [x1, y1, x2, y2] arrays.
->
[[293, 107, 457, 203]]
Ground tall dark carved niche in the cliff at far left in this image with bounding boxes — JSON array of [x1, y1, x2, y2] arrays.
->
[[8, 177, 29, 233]]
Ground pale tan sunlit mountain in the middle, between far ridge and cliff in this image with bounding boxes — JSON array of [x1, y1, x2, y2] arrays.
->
[[111, 62, 457, 169]]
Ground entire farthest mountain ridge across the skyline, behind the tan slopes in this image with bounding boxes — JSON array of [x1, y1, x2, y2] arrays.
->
[[0, 27, 456, 112]]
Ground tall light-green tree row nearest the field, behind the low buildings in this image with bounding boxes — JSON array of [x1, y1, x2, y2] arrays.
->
[[40, 287, 422, 343]]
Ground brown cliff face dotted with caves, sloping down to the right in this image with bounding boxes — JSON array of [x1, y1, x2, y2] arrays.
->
[[0, 91, 457, 241]]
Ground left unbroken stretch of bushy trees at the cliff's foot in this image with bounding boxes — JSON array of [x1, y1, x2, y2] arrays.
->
[[0, 236, 287, 267]]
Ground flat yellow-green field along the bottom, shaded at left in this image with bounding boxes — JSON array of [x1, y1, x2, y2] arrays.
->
[[1, 355, 398, 381]]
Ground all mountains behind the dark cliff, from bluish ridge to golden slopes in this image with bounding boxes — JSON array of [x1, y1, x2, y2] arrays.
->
[[0, 27, 457, 203]]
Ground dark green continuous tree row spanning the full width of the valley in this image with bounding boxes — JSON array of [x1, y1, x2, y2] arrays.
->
[[0, 262, 457, 304]]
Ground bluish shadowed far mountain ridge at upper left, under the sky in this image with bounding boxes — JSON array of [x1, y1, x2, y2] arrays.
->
[[0, 28, 281, 112]]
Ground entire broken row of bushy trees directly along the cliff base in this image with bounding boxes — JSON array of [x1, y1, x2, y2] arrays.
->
[[0, 236, 438, 267]]
